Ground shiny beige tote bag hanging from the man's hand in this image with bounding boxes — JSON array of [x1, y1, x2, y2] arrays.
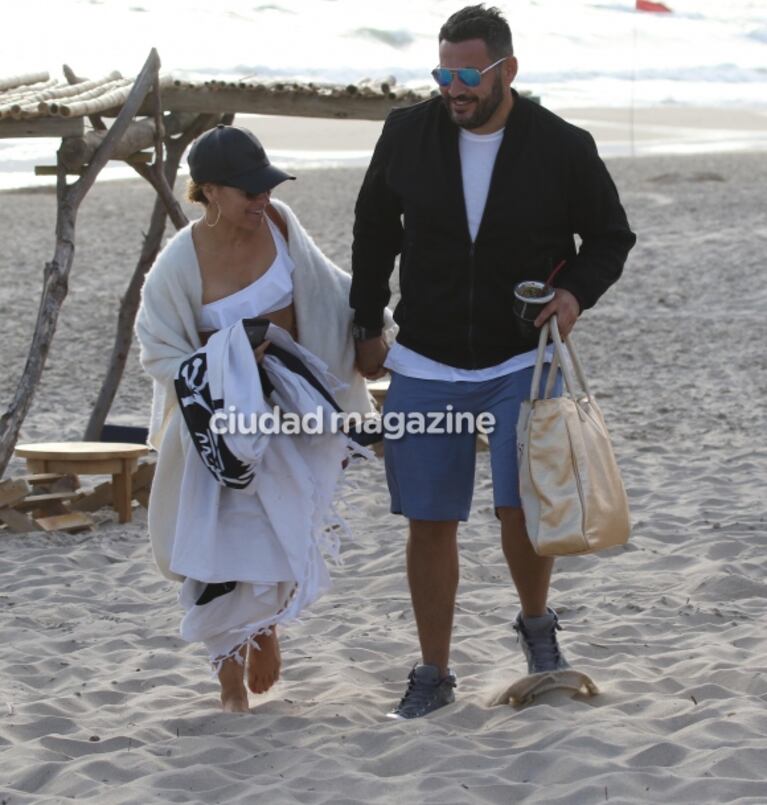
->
[[517, 317, 631, 556]]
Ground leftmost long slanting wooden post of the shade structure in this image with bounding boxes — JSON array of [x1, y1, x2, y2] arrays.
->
[[0, 49, 160, 475]]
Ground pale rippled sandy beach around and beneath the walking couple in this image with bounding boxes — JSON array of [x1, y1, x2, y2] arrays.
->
[[0, 122, 767, 805]]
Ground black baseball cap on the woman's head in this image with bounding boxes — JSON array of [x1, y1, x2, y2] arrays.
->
[[187, 123, 296, 195]]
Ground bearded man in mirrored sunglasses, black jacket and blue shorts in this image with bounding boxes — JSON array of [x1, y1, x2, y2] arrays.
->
[[350, 5, 635, 718]]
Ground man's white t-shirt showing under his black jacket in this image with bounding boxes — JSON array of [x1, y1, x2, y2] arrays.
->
[[384, 124, 551, 382]]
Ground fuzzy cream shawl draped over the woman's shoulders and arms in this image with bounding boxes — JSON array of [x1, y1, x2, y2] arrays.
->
[[136, 199, 393, 581]]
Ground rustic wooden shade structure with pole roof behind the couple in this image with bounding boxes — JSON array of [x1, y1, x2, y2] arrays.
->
[[0, 56, 430, 475]]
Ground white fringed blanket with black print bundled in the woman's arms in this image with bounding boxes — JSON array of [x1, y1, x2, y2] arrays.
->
[[170, 322, 350, 671]]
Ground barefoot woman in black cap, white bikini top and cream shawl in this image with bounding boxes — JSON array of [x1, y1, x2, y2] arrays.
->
[[136, 125, 384, 712]]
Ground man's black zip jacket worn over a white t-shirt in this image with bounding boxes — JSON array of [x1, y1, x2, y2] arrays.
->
[[350, 92, 636, 369]]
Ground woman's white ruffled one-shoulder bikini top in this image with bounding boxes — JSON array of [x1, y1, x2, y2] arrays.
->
[[199, 216, 295, 331]]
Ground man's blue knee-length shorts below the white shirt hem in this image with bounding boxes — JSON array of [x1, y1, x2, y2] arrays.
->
[[384, 364, 562, 520]]
